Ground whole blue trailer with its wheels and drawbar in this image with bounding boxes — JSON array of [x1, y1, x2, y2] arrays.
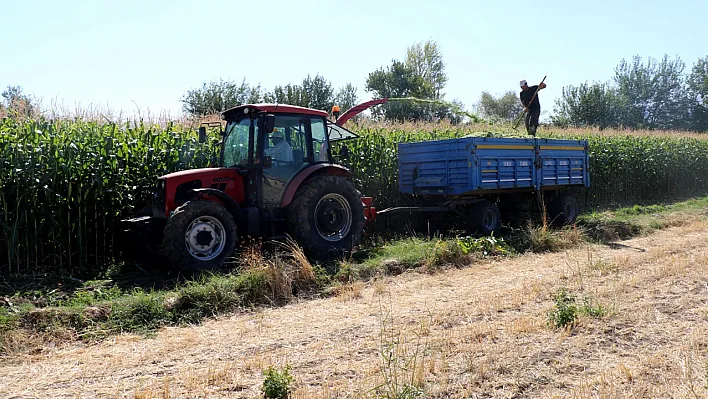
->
[[379, 137, 590, 234]]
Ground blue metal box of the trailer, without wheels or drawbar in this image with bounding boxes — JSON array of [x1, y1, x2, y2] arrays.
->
[[398, 137, 590, 196]]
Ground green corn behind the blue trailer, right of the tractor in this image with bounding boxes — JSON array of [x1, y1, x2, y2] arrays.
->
[[346, 127, 708, 209]]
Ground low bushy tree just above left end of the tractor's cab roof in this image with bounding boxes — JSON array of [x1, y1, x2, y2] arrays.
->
[[181, 79, 262, 115]]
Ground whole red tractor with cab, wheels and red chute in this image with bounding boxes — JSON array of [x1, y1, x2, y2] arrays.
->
[[124, 100, 385, 270]]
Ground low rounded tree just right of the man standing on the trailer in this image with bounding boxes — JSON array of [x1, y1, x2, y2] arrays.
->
[[551, 82, 623, 129]]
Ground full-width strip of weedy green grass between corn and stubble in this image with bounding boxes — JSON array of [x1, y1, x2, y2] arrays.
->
[[0, 197, 708, 357]]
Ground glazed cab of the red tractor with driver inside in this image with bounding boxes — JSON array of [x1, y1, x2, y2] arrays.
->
[[220, 104, 357, 209]]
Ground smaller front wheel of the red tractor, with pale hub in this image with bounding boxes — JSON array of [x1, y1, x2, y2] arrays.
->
[[163, 201, 238, 271]]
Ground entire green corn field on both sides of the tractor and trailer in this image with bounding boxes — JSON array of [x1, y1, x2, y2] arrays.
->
[[0, 118, 708, 275]]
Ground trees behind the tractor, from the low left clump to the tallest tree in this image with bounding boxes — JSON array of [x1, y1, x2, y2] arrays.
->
[[181, 40, 464, 123]]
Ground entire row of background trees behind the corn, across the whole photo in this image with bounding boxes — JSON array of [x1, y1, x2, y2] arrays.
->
[[0, 47, 708, 131]]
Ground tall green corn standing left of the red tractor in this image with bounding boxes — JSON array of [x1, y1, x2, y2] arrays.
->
[[0, 118, 216, 275]]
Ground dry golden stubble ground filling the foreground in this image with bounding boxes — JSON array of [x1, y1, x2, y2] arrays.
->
[[0, 222, 708, 398]]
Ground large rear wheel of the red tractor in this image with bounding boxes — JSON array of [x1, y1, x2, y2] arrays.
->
[[288, 175, 365, 259]]
